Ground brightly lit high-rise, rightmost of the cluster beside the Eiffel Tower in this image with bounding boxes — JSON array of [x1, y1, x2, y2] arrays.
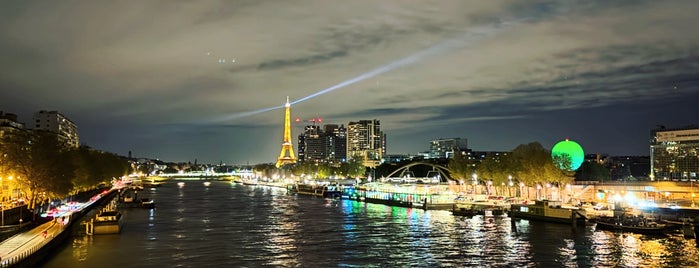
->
[[347, 119, 386, 167]]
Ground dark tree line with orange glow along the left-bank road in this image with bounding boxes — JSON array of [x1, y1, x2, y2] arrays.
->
[[0, 130, 132, 209]]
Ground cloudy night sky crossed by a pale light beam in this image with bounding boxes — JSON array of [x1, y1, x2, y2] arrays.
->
[[0, 0, 699, 164]]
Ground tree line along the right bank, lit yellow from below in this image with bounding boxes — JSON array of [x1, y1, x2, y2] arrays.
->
[[254, 142, 610, 187]]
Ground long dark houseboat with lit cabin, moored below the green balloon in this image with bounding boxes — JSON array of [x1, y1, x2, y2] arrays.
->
[[510, 200, 587, 224]]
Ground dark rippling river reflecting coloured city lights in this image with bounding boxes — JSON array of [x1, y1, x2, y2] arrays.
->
[[43, 181, 699, 268]]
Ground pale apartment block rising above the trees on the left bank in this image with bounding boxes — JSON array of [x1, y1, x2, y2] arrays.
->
[[34, 110, 80, 147]]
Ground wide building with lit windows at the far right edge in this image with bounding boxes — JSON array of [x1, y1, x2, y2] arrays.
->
[[649, 126, 699, 181]]
